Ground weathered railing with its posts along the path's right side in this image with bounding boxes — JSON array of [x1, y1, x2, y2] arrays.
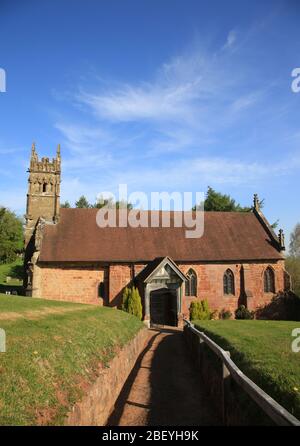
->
[[184, 320, 300, 426]]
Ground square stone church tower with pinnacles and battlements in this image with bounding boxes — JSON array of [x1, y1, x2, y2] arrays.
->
[[25, 144, 61, 248]]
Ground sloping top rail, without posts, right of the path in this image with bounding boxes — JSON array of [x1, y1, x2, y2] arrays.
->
[[184, 319, 300, 426]]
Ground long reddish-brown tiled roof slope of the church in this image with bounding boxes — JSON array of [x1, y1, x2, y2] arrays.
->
[[40, 209, 283, 262]]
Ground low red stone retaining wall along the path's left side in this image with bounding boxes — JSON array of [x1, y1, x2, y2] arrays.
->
[[64, 328, 150, 426]]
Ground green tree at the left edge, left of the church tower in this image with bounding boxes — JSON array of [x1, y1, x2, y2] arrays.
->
[[0, 207, 24, 263]]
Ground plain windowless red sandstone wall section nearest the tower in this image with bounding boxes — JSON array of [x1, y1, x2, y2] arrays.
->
[[35, 265, 104, 305]]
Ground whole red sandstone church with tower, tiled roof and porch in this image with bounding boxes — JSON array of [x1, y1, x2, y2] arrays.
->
[[24, 145, 289, 326]]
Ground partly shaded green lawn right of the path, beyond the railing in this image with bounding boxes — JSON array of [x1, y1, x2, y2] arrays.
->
[[194, 320, 300, 419]]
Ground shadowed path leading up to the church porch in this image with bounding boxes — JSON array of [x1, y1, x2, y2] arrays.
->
[[108, 328, 220, 426]]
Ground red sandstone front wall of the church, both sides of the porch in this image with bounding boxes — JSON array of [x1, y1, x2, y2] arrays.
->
[[34, 260, 284, 317]]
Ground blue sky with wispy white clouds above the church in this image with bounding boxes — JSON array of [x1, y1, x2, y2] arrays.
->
[[0, 0, 300, 242]]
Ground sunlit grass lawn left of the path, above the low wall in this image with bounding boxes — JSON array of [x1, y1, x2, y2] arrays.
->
[[0, 294, 144, 425]]
